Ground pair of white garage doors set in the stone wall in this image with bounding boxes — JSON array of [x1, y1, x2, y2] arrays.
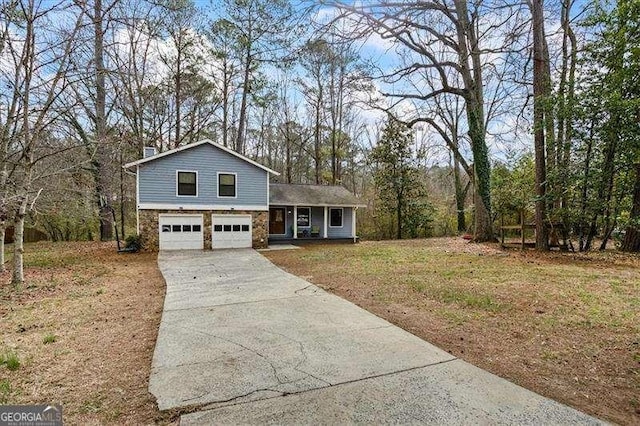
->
[[158, 214, 252, 250]]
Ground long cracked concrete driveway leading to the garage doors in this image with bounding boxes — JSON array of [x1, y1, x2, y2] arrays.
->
[[149, 249, 599, 424]]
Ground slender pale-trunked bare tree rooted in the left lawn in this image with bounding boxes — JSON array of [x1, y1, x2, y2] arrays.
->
[[3, 0, 82, 287]]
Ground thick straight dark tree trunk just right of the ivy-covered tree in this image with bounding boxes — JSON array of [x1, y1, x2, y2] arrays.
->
[[531, 0, 549, 250]]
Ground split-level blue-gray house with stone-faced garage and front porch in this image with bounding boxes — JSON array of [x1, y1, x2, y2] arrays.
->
[[124, 140, 366, 250]]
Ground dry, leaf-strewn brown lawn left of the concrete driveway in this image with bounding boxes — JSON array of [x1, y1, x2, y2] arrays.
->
[[0, 243, 169, 425]]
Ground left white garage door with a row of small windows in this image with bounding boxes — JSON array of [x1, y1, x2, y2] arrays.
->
[[158, 214, 204, 250]]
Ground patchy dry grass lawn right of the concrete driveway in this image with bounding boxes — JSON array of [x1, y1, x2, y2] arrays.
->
[[265, 239, 640, 424]]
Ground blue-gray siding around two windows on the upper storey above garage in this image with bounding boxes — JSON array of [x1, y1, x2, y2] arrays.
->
[[138, 144, 269, 206]]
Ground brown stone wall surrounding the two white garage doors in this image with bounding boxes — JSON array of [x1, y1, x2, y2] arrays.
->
[[139, 210, 269, 251]]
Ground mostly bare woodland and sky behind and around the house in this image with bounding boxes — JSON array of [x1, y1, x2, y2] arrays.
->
[[0, 0, 640, 283]]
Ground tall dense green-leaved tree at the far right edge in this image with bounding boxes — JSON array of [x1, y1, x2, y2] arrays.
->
[[581, 0, 640, 251]]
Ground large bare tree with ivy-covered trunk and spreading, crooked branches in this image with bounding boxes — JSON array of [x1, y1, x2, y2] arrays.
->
[[332, 0, 505, 241]]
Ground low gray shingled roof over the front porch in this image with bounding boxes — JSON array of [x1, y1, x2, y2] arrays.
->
[[269, 183, 367, 207]]
